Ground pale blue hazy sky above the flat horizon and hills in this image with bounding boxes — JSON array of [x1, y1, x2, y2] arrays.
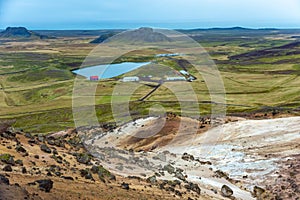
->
[[0, 0, 300, 29]]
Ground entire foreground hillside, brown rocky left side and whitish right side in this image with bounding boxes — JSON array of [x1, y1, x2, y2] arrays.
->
[[0, 114, 300, 200]]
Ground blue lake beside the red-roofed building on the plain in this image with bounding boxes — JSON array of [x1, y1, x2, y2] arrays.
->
[[73, 62, 150, 79]]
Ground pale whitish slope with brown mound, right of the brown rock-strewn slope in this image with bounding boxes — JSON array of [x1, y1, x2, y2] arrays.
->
[[80, 116, 300, 200]]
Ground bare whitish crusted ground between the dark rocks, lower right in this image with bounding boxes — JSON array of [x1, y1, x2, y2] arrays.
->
[[87, 117, 300, 199]]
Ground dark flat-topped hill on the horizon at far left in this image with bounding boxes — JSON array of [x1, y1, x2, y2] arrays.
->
[[0, 27, 49, 39]]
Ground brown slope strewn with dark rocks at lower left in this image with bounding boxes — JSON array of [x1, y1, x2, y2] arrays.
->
[[0, 122, 211, 200]]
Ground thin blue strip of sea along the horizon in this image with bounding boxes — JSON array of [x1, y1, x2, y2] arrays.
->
[[0, 20, 299, 30]]
